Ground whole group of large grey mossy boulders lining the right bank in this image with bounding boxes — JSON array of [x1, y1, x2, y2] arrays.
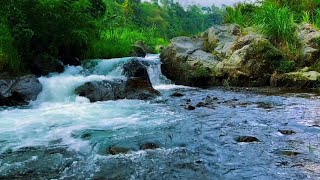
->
[[160, 24, 320, 88]]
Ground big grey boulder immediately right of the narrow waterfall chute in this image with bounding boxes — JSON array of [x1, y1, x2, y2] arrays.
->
[[160, 37, 218, 86]]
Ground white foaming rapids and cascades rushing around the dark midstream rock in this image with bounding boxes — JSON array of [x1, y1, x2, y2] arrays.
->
[[0, 55, 175, 152]]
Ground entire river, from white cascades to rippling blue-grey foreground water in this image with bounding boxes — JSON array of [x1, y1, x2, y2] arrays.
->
[[0, 56, 320, 180]]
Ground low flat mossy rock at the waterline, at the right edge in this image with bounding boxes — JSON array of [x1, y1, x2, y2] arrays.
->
[[271, 68, 320, 88]]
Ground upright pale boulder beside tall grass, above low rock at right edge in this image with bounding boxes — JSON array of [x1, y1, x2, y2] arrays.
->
[[298, 24, 320, 67]]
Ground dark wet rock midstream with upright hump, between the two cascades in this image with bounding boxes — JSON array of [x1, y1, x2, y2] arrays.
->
[[75, 58, 160, 102]]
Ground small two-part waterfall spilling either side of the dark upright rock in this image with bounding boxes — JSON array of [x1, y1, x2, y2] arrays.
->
[[33, 55, 169, 104]]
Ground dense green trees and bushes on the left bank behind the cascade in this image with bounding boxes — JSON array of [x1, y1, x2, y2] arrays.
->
[[0, 0, 223, 73]]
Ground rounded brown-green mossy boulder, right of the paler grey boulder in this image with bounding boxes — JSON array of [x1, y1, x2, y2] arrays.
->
[[215, 35, 282, 86]]
